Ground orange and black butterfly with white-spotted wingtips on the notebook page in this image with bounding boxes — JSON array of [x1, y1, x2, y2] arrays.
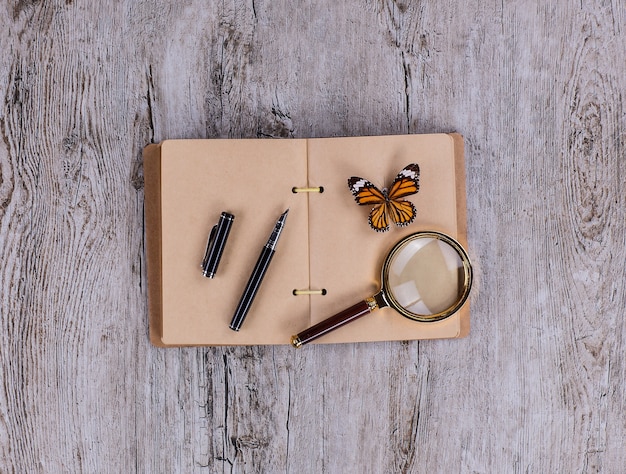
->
[[348, 163, 420, 232]]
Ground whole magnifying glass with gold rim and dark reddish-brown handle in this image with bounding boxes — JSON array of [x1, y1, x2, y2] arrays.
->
[[291, 231, 472, 347]]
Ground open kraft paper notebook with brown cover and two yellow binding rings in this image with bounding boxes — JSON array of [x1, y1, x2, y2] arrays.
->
[[144, 134, 469, 346]]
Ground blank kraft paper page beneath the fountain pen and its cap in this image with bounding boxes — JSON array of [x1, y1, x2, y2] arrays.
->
[[161, 140, 309, 345]]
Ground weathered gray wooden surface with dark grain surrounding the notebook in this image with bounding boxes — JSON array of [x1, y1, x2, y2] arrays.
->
[[0, 0, 626, 473]]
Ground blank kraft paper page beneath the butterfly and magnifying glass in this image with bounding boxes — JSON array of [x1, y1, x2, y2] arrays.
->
[[309, 134, 460, 342]]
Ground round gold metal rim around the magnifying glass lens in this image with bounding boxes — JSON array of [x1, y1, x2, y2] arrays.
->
[[374, 231, 473, 322]]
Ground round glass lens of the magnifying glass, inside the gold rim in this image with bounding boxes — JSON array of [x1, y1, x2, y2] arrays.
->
[[386, 237, 465, 316]]
